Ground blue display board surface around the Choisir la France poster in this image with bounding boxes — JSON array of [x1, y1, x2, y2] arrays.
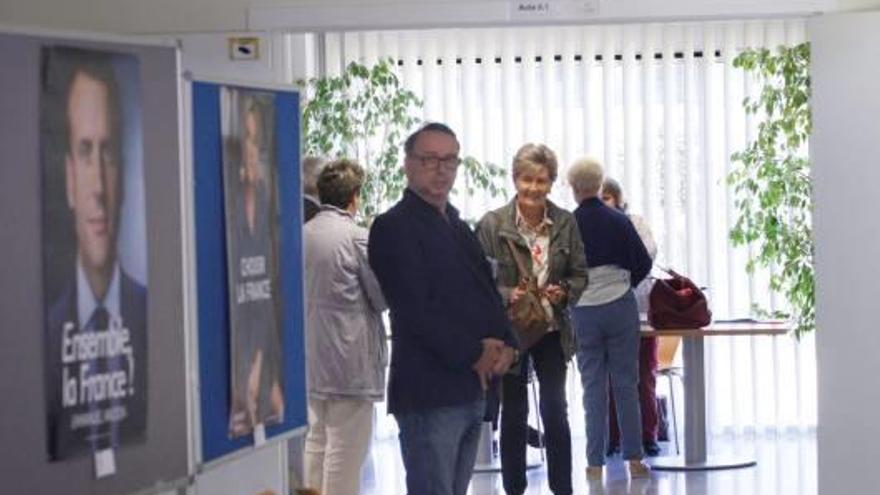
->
[[192, 81, 307, 463]]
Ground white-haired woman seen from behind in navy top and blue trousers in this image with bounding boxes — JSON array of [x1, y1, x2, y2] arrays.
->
[[568, 159, 651, 480]]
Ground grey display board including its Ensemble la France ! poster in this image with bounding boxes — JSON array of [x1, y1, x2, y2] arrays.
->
[[0, 32, 188, 494]]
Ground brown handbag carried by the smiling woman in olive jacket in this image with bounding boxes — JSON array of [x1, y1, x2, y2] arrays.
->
[[507, 239, 550, 351]]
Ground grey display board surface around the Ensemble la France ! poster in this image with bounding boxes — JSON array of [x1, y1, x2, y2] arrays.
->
[[0, 34, 187, 494]]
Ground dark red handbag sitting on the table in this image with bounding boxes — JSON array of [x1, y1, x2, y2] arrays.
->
[[648, 270, 712, 330]]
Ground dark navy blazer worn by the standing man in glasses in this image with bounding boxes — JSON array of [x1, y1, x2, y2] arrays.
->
[[368, 190, 516, 414]]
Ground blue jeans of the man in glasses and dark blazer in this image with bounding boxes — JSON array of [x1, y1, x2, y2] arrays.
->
[[394, 399, 486, 495]]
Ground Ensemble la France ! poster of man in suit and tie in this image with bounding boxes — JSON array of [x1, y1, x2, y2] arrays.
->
[[39, 46, 147, 460]]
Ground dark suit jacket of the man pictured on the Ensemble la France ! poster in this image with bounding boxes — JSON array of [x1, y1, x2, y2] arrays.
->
[[43, 268, 148, 460]]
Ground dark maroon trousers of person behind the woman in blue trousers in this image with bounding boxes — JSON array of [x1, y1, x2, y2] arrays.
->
[[608, 337, 660, 445]]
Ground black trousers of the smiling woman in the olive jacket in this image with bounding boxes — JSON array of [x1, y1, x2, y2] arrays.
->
[[501, 332, 572, 495]]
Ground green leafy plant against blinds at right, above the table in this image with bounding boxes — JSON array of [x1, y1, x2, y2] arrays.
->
[[727, 43, 816, 337]]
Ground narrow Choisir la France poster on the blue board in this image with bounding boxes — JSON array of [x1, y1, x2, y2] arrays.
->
[[220, 87, 284, 437]]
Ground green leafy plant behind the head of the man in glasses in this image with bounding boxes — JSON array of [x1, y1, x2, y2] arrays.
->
[[298, 59, 504, 225]]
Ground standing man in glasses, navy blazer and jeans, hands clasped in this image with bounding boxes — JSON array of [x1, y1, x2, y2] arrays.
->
[[368, 123, 516, 495]]
